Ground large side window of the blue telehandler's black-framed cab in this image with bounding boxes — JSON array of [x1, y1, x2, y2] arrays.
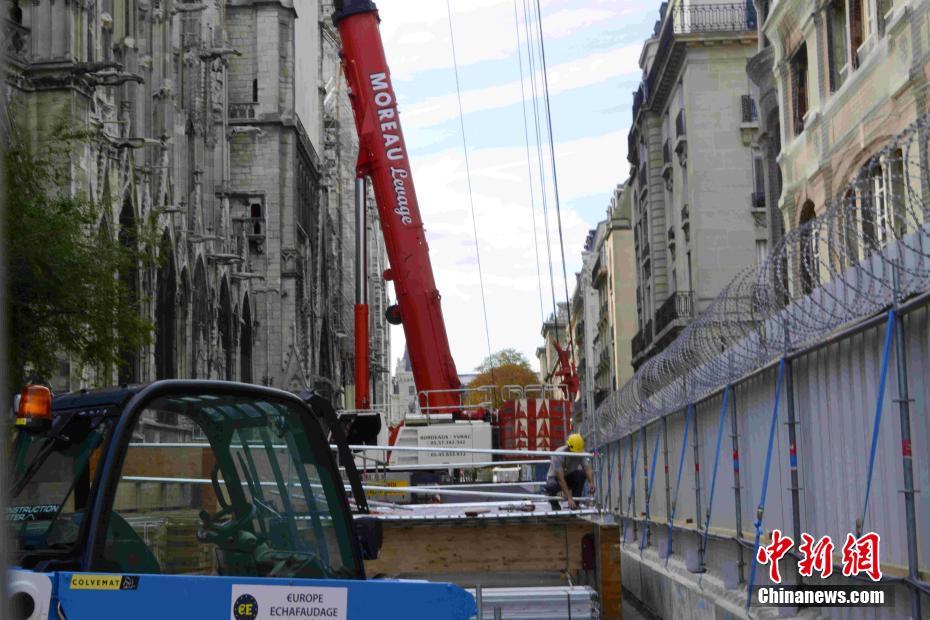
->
[[101, 393, 360, 578]]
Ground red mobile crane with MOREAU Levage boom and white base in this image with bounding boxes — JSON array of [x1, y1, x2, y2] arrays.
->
[[334, 0, 578, 472]]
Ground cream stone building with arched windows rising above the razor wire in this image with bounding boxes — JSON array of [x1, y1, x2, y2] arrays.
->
[[759, 0, 930, 240]]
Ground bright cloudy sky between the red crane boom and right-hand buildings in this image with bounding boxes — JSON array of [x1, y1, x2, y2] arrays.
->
[[377, 0, 659, 372]]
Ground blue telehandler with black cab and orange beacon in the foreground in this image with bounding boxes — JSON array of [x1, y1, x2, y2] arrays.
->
[[7, 381, 474, 620]]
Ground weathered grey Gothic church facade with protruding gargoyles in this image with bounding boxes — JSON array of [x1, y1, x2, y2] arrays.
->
[[5, 0, 388, 404]]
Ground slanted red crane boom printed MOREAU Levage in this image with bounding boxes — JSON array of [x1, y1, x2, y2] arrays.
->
[[333, 0, 461, 412]]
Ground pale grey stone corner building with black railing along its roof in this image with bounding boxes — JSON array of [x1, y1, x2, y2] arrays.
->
[[628, 0, 768, 367]]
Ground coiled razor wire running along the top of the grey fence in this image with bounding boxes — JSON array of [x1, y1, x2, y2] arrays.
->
[[581, 114, 930, 446]]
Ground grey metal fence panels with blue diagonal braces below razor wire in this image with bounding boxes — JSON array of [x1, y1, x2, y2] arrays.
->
[[604, 306, 930, 618]]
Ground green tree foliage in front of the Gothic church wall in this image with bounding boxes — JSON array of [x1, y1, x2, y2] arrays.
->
[[3, 109, 153, 390]]
